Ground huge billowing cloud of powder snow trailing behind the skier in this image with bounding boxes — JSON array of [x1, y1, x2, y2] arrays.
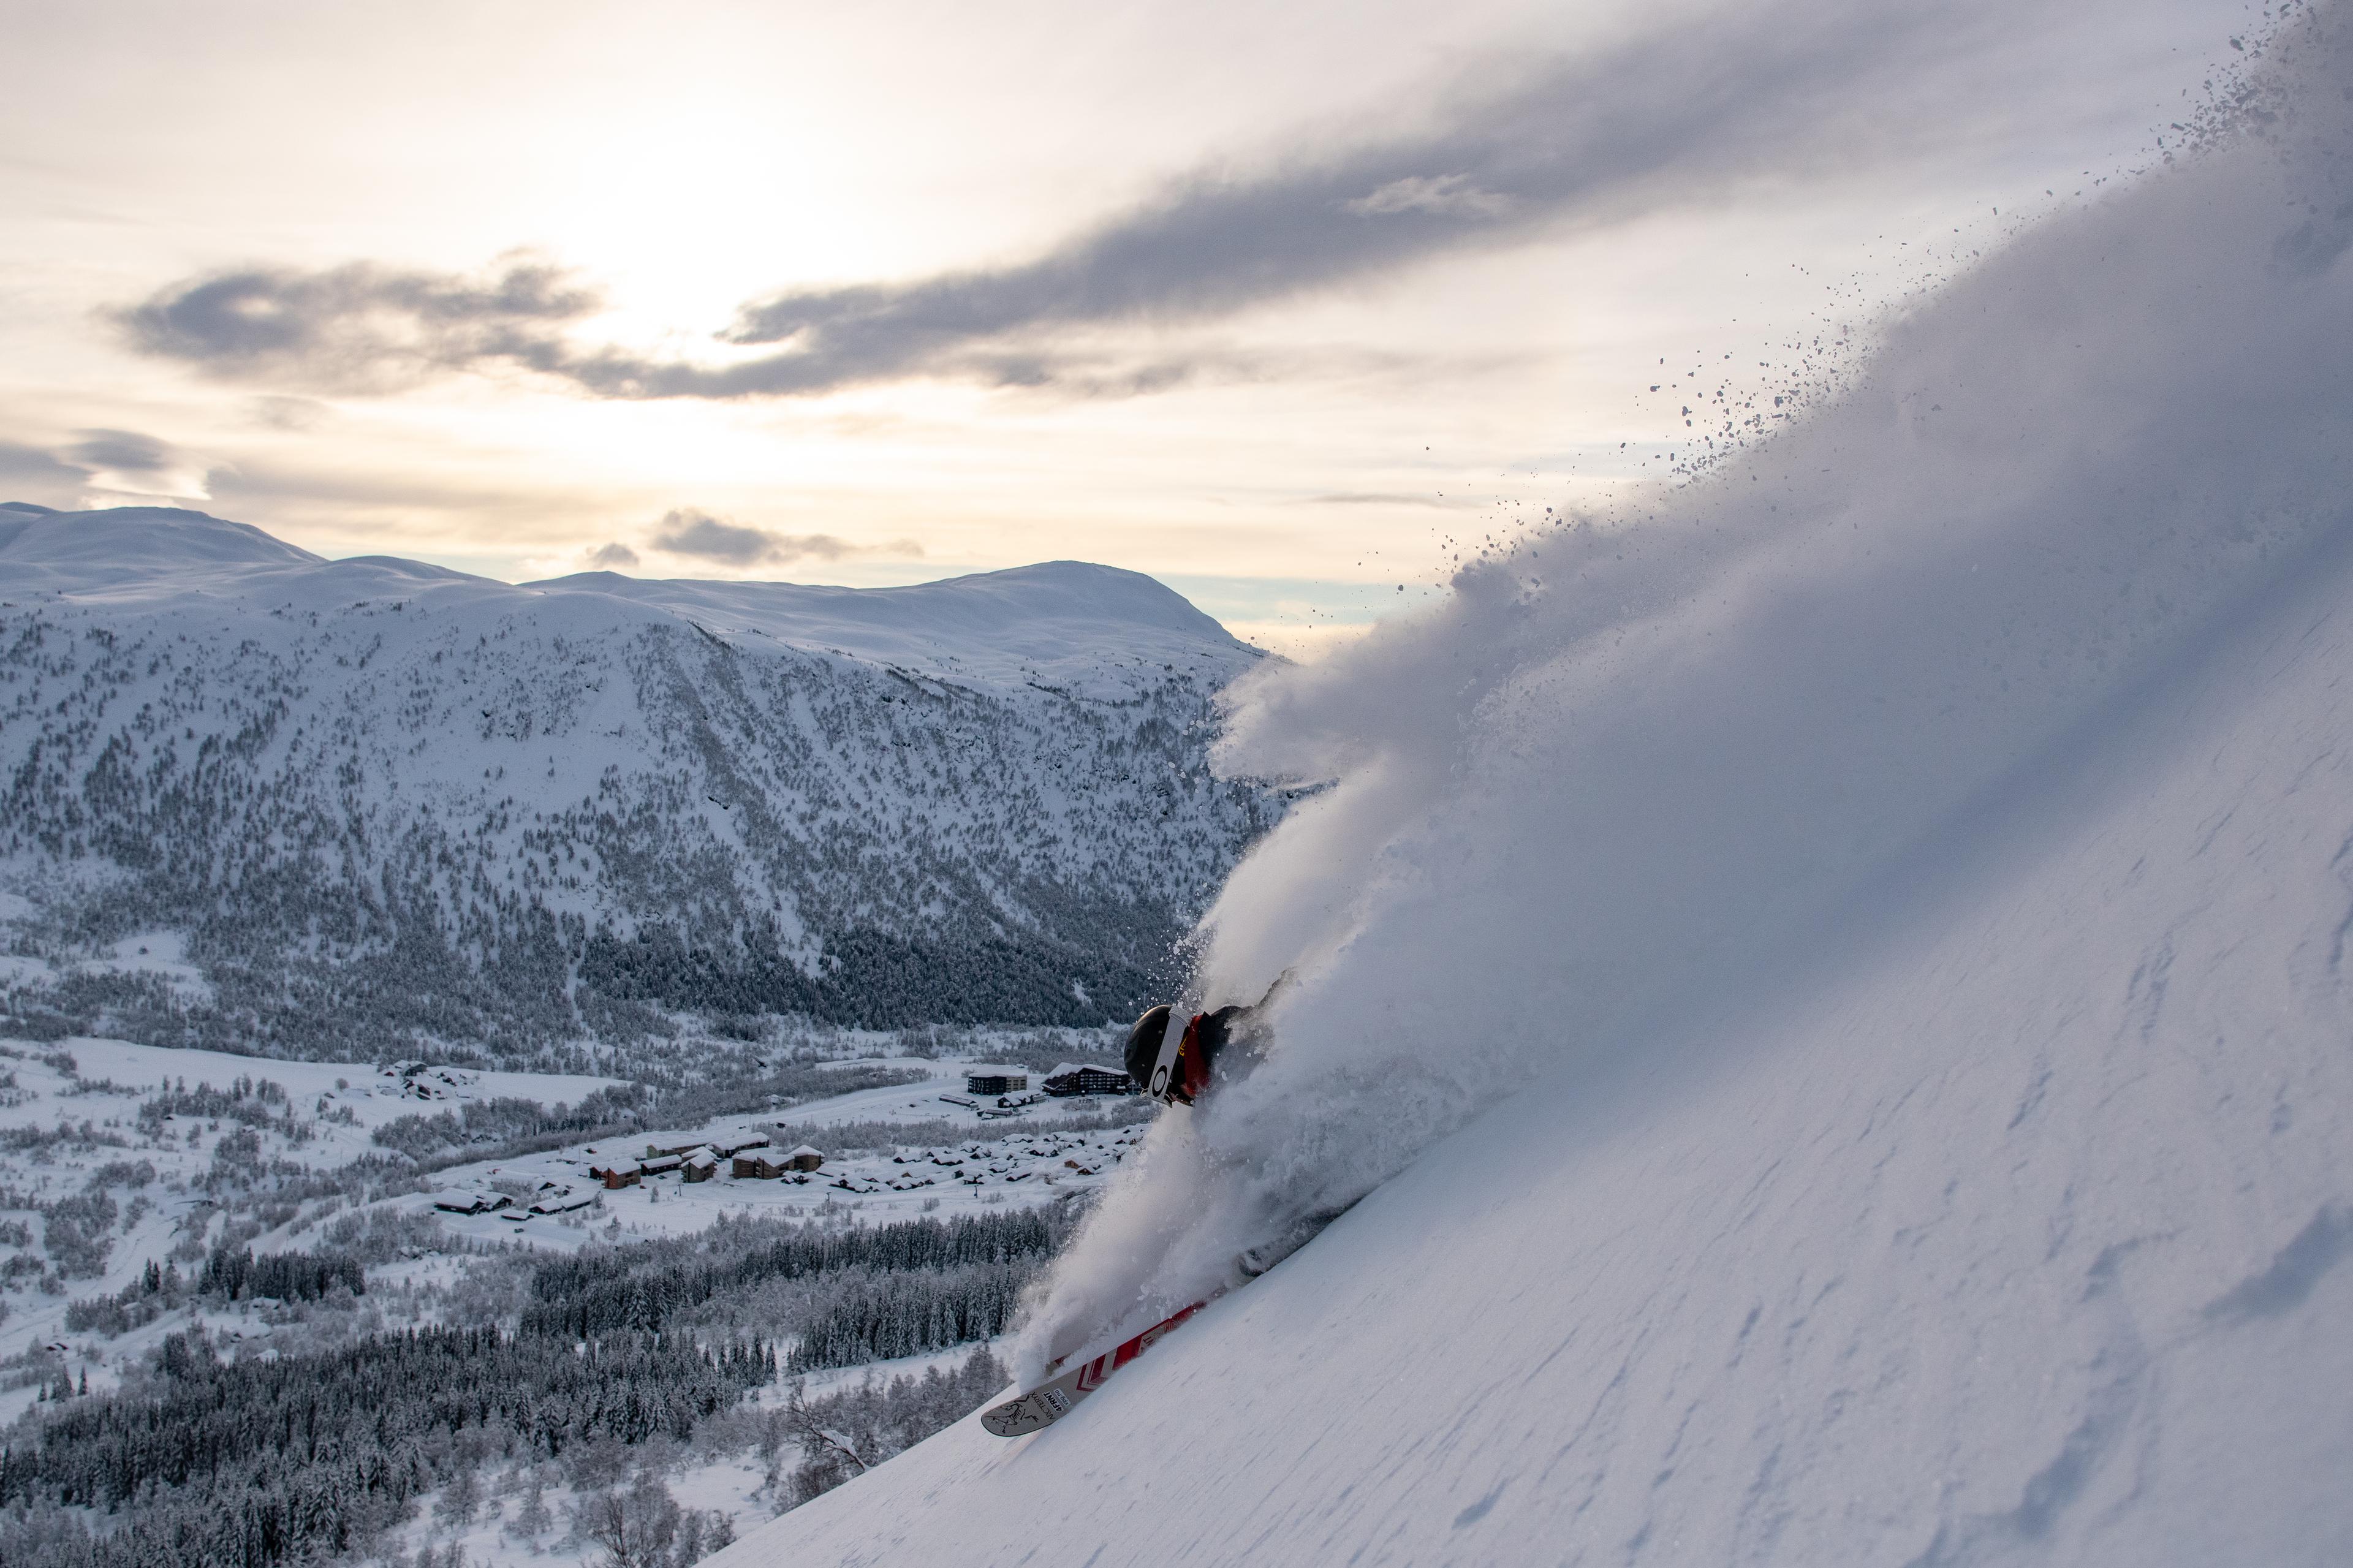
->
[[1017, 12, 2353, 1370]]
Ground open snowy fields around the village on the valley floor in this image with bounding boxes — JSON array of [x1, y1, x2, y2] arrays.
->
[[0, 1038, 1141, 1417]]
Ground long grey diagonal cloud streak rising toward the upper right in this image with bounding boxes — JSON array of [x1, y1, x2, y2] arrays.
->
[[701, 5, 2004, 391]]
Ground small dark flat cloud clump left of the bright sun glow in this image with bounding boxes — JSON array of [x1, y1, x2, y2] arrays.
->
[[113, 259, 602, 391]]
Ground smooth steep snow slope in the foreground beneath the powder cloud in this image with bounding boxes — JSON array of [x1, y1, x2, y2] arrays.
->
[[718, 513, 2353, 1568]]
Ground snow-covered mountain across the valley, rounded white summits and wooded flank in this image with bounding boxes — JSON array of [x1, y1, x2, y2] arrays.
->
[[0, 506, 1280, 1057]]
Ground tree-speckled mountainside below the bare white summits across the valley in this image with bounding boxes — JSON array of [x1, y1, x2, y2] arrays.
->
[[0, 605, 1285, 1067]]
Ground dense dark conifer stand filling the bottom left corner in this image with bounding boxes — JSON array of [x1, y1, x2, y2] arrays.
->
[[0, 1328, 776, 1568]]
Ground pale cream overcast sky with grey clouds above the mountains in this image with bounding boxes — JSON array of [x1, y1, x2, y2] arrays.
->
[[0, 0, 2254, 645]]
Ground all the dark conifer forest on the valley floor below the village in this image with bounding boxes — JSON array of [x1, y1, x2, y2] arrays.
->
[[0, 1208, 1073, 1568]]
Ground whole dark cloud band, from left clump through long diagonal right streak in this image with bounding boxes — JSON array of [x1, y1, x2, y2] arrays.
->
[[105, 0, 2061, 403]]
